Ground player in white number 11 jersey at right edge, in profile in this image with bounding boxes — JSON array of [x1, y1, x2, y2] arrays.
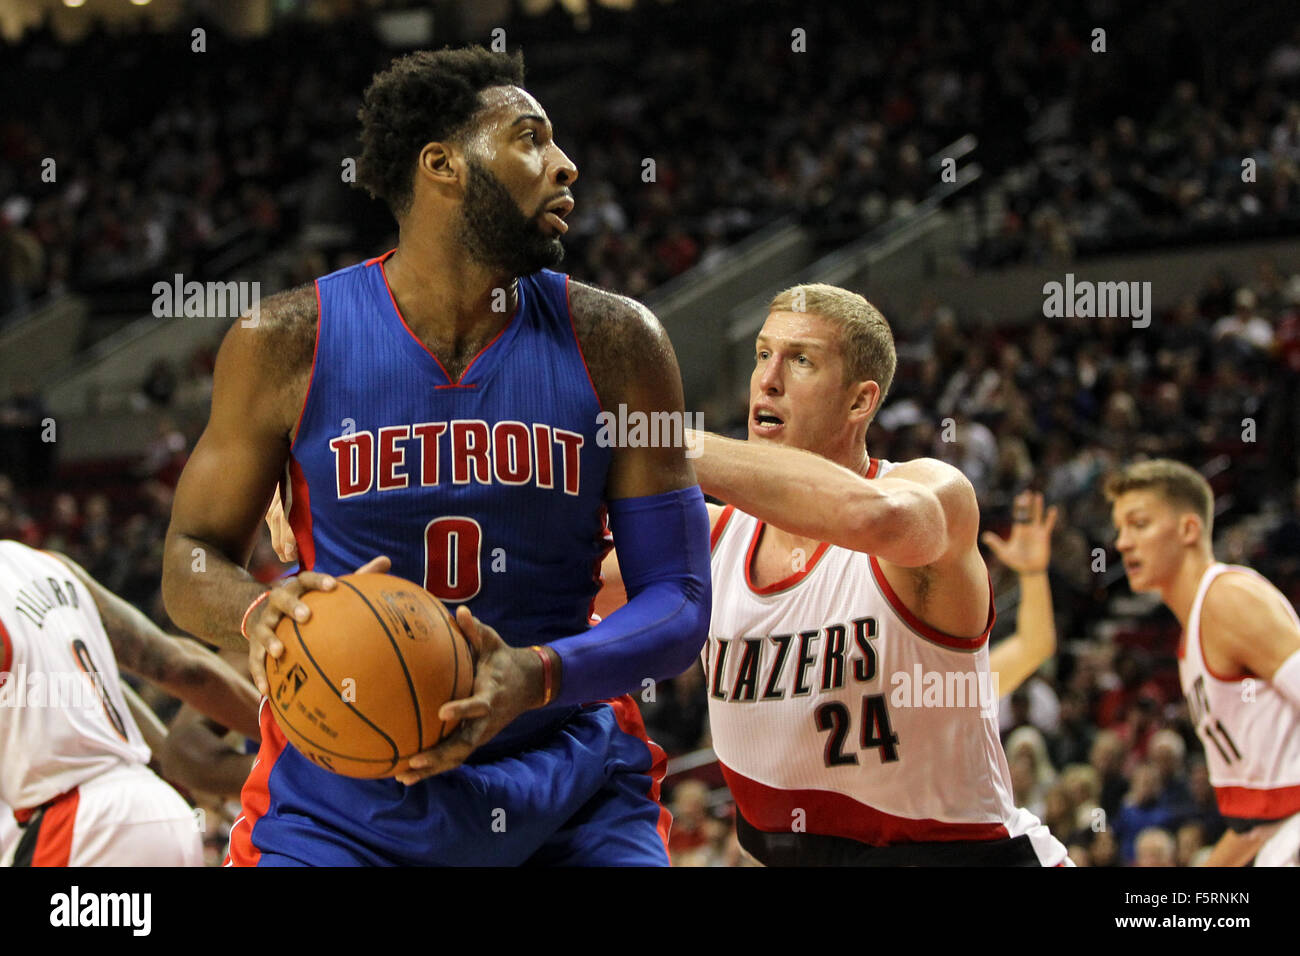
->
[[1105, 459, 1300, 866]]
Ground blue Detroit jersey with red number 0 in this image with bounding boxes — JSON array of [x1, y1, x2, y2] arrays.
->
[[289, 252, 611, 759]]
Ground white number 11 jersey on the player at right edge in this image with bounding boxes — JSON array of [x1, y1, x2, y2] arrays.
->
[[1178, 563, 1300, 829]]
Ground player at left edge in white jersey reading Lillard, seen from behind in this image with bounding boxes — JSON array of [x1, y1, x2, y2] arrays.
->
[[0, 541, 257, 866]]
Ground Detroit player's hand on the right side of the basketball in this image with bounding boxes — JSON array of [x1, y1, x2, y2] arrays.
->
[[397, 605, 553, 784]]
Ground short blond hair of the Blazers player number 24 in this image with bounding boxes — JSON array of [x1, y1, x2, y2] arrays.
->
[[767, 282, 898, 408]]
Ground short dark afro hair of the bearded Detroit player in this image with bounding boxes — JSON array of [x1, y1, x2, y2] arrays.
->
[[356, 47, 524, 216]]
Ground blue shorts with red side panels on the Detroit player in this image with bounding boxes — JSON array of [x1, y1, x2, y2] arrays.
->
[[226, 696, 672, 866]]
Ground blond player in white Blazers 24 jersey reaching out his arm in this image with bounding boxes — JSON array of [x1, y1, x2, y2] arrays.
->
[[696, 285, 1067, 866]]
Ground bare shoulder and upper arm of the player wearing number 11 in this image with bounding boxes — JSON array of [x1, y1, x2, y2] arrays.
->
[[1200, 572, 1300, 680]]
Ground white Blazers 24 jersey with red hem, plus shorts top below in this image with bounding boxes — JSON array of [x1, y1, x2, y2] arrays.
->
[[702, 459, 1069, 865]]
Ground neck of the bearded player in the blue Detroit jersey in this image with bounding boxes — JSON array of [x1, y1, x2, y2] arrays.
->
[[384, 226, 519, 338]]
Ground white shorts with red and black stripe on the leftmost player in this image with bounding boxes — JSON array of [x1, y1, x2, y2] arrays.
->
[[9, 763, 203, 866]]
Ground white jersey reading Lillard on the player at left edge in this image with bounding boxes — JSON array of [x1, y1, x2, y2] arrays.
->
[[0, 541, 150, 810]]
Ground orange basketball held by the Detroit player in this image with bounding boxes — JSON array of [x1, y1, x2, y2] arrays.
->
[[267, 574, 475, 778]]
